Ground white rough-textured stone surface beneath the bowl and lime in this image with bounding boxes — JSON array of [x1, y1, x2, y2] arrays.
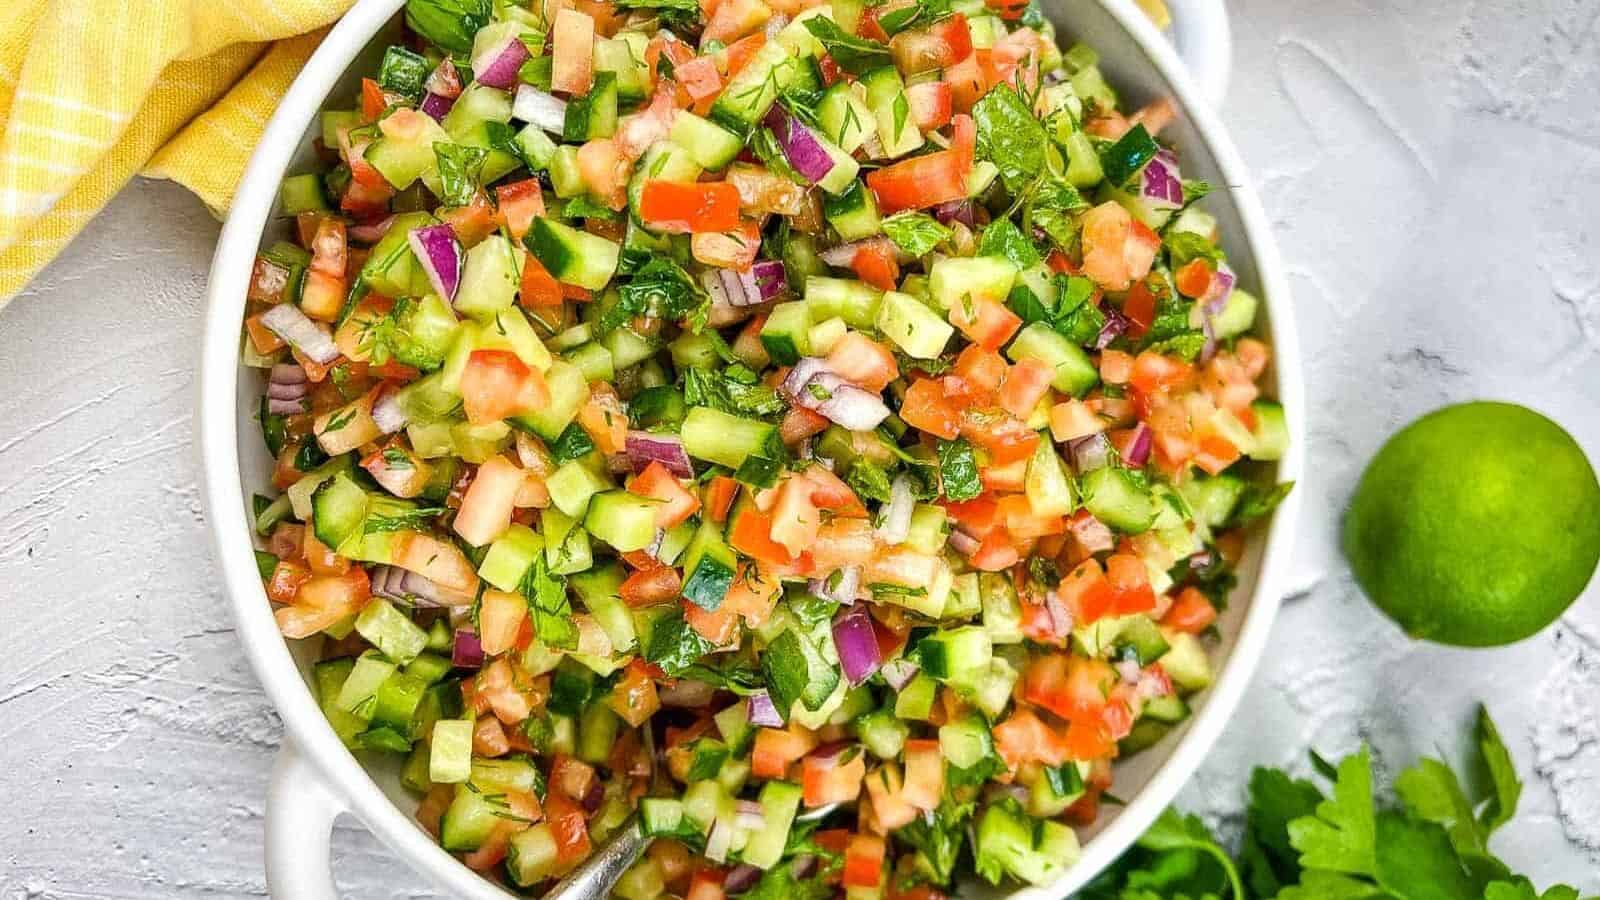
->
[[0, 0, 1600, 900]]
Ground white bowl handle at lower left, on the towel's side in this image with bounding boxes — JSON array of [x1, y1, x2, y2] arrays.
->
[[267, 738, 346, 900]]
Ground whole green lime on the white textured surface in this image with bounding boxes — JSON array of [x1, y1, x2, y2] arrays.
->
[[1344, 402, 1600, 647]]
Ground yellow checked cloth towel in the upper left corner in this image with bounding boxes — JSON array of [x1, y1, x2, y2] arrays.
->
[[0, 0, 352, 306]]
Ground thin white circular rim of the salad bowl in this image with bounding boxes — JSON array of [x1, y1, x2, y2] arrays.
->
[[197, 0, 1306, 900]]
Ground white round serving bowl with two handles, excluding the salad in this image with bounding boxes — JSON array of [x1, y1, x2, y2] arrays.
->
[[198, 0, 1304, 900]]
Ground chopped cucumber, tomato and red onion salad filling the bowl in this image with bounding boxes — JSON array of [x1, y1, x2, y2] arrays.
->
[[243, 0, 1288, 883]]
